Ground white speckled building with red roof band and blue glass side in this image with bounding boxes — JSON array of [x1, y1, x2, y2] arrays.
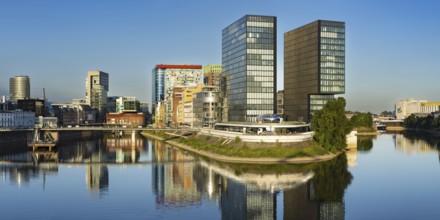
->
[[152, 64, 203, 110]]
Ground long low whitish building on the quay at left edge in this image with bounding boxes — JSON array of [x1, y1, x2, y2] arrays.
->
[[0, 111, 35, 128]]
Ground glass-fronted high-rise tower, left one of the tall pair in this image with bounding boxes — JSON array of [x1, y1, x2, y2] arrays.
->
[[222, 15, 277, 122]]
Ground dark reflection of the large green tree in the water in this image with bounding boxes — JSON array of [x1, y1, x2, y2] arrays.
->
[[311, 154, 353, 202]]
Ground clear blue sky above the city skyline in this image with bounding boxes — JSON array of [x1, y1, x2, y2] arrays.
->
[[0, 0, 440, 113]]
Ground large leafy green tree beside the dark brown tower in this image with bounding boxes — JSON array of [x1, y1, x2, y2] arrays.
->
[[310, 97, 351, 152]]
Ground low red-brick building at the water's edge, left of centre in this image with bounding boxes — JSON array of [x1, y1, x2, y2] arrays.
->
[[106, 112, 145, 127]]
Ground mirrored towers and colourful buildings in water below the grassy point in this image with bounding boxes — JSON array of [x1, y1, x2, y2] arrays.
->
[[152, 142, 352, 219]]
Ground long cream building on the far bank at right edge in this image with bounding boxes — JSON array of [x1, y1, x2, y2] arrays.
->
[[395, 98, 440, 120]]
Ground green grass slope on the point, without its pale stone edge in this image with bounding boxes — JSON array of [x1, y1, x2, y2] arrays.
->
[[141, 131, 329, 158]]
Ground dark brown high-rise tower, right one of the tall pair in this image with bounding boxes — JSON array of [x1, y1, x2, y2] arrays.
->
[[284, 20, 345, 121]]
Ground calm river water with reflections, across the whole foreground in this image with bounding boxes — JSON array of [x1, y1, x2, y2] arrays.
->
[[0, 133, 440, 220]]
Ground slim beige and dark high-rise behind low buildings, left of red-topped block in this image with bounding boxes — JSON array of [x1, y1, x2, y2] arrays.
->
[[86, 70, 109, 122]]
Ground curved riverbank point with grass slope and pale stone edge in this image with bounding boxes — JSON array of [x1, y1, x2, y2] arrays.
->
[[141, 131, 338, 164]]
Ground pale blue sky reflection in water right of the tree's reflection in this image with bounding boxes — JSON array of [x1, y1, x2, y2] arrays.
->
[[345, 135, 440, 219]]
